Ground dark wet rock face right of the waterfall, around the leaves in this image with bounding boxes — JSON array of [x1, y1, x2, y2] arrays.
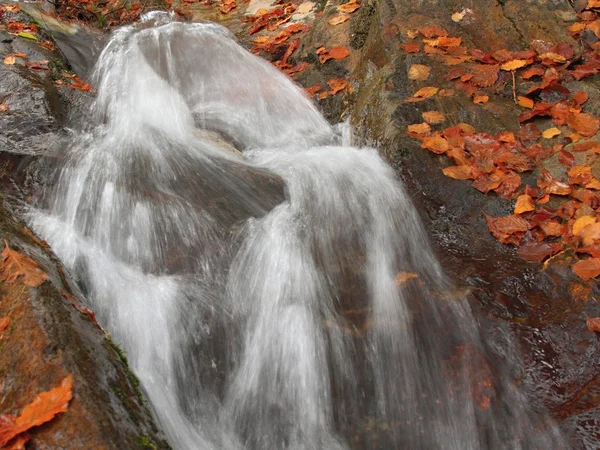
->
[[352, 0, 600, 449]]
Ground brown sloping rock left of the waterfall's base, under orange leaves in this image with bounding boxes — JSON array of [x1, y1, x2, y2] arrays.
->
[[0, 203, 169, 450]]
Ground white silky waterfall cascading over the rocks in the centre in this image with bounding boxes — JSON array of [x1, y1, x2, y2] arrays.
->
[[30, 14, 566, 450]]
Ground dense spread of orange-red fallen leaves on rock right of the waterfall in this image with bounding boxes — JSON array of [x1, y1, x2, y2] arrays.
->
[[403, 1, 600, 278]]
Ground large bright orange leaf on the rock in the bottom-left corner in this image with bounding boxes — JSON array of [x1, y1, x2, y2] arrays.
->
[[0, 375, 73, 446]]
